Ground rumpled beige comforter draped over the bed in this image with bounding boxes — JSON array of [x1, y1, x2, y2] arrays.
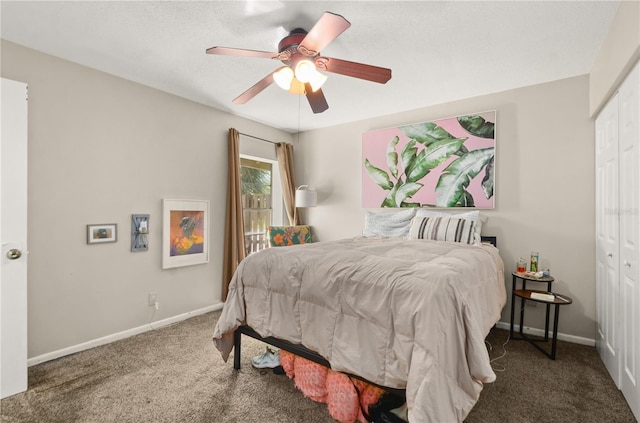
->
[[213, 237, 506, 423]]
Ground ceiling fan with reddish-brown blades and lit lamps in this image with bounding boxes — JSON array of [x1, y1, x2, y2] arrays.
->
[[207, 12, 391, 113]]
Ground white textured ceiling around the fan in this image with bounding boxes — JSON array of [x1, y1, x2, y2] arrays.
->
[[0, 0, 619, 132]]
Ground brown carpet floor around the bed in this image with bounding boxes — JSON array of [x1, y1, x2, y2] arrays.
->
[[0, 311, 636, 423]]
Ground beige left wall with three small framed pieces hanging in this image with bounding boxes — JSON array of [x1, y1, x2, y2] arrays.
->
[[2, 41, 291, 358]]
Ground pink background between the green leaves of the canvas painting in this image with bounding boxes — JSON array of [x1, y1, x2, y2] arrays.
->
[[362, 111, 496, 209]]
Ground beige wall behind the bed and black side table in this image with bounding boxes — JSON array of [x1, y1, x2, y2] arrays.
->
[[296, 75, 595, 341]]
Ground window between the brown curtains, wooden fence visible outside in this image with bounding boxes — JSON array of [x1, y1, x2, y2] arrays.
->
[[240, 156, 282, 255]]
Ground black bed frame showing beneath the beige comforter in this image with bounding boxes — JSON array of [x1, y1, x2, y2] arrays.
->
[[233, 236, 496, 396]]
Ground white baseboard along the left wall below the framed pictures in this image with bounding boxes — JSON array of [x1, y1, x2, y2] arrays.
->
[[27, 303, 224, 367]]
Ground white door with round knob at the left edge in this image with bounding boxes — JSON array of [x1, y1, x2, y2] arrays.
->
[[0, 78, 27, 398]]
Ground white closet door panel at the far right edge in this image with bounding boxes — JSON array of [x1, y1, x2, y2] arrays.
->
[[618, 61, 640, 418]]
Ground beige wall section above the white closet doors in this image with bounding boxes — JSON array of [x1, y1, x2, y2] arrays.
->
[[589, 0, 640, 116]]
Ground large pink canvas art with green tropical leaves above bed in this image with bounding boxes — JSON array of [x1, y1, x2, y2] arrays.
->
[[362, 110, 496, 209]]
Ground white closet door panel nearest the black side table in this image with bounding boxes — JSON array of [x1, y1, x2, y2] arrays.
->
[[595, 91, 620, 387]]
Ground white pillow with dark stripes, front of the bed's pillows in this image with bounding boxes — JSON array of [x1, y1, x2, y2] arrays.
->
[[409, 217, 476, 244]]
